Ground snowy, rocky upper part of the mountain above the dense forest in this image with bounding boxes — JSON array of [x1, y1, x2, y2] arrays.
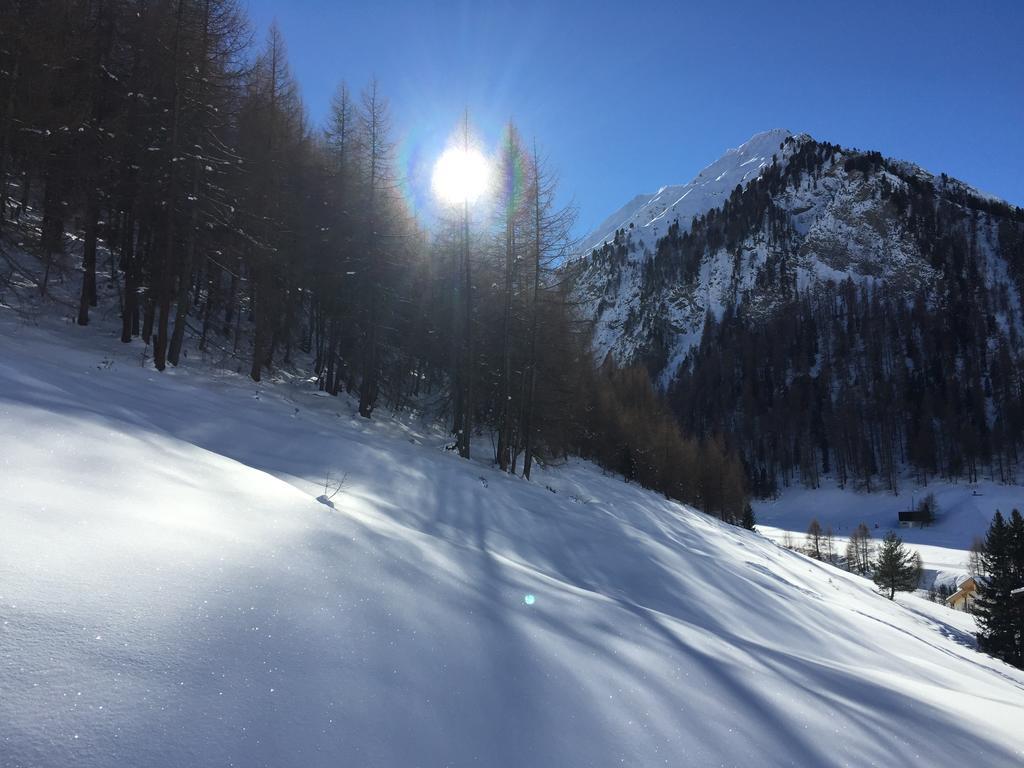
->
[[574, 130, 1024, 386]]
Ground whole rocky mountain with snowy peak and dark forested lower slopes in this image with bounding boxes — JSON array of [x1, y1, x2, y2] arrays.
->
[[571, 131, 1024, 494]]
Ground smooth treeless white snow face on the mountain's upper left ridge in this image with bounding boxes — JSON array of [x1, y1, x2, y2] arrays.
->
[[580, 128, 792, 254]]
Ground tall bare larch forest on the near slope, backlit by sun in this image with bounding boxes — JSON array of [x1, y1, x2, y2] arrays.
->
[[0, 0, 745, 519]]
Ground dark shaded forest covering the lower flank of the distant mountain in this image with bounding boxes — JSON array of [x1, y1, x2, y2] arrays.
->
[[670, 280, 1024, 496]]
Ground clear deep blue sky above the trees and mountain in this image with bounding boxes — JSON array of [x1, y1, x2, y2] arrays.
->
[[242, 0, 1024, 234]]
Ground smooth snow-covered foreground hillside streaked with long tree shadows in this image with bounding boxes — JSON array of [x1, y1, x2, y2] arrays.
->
[[6, 314, 1024, 768]]
